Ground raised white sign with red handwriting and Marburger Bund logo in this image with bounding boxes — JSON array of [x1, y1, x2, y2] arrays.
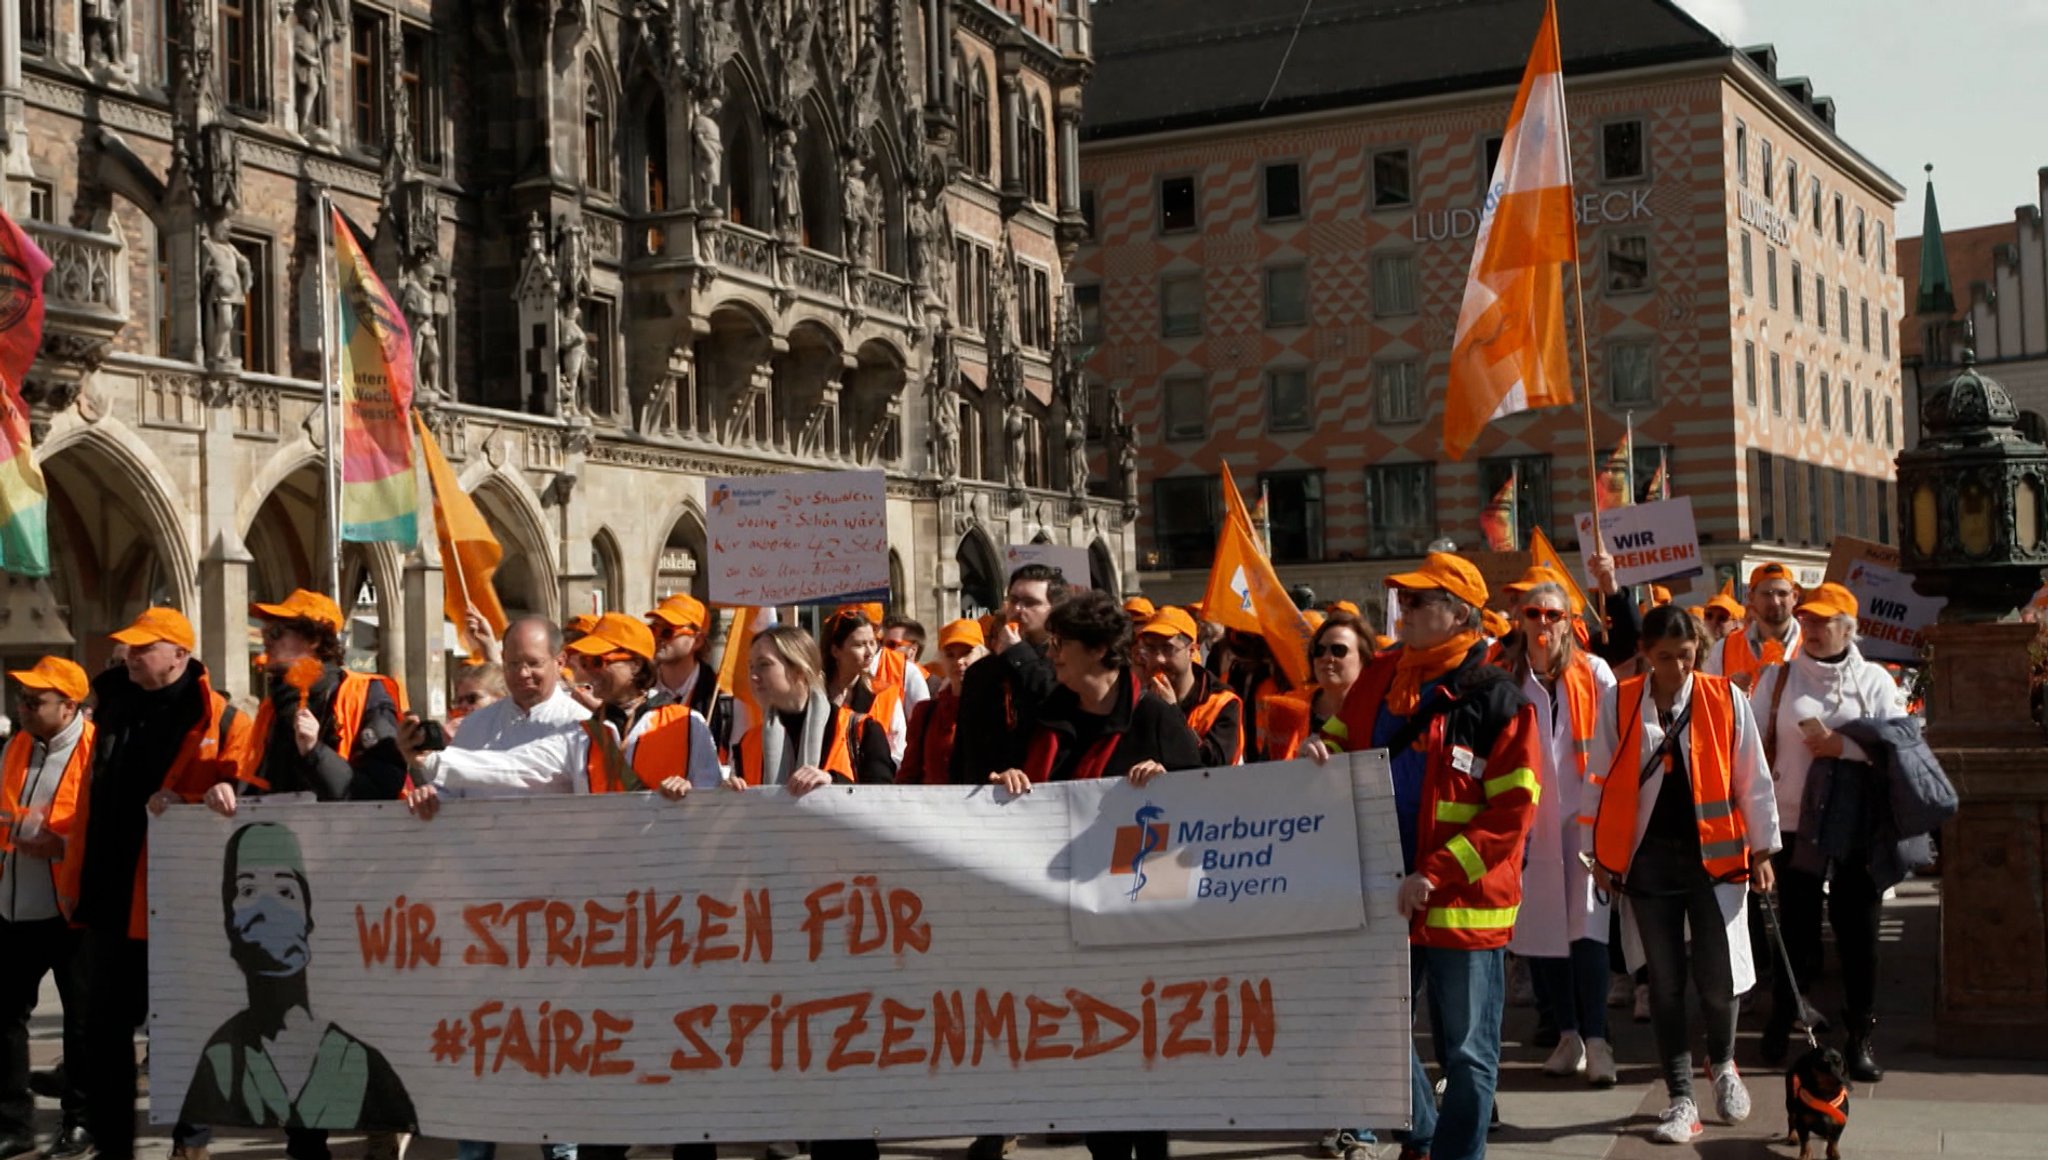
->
[[705, 471, 889, 607]]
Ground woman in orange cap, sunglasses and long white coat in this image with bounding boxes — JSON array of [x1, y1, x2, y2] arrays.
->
[[1495, 568, 1614, 1088]]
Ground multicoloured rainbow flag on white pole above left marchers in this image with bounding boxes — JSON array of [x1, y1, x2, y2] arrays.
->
[[330, 207, 420, 545]]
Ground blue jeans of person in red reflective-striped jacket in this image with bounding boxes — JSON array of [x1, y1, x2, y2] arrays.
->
[[1409, 947, 1507, 1160]]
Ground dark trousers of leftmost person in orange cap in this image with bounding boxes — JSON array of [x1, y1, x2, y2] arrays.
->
[[0, 918, 86, 1140]]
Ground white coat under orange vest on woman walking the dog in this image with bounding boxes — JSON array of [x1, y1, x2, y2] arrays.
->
[[1583, 676, 1782, 994]]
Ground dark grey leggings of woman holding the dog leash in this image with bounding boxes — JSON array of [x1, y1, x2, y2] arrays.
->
[[1628, 864, 1737, 1101]]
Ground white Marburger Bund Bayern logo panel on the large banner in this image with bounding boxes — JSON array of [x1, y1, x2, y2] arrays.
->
[[1067, 750, 1380, 947]]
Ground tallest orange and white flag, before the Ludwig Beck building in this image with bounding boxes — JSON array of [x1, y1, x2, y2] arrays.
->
[[1444, 0, 1579, 459]]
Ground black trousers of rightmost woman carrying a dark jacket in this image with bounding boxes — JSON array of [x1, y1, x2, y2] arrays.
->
[[1772, 836, 1884, 1025]]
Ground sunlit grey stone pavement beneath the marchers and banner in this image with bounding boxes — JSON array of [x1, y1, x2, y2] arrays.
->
[[19, 881, 2048, 1160]]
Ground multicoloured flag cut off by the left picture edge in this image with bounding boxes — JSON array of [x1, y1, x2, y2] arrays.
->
[[0, 211, 49, 576]]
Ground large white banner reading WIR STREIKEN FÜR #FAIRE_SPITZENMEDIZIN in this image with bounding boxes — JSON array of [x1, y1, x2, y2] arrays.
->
[[150, 750, 1411, 1144]]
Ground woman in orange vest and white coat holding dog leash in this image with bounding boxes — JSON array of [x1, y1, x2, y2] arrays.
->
[[1579, 605, 1778, 1144]]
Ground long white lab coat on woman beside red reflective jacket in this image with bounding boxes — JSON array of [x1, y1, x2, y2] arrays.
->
[[1507, 656, 1614, 959]]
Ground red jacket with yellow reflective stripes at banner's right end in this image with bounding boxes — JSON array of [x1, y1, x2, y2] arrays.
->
[[1337, 646, 1542, 951]]
